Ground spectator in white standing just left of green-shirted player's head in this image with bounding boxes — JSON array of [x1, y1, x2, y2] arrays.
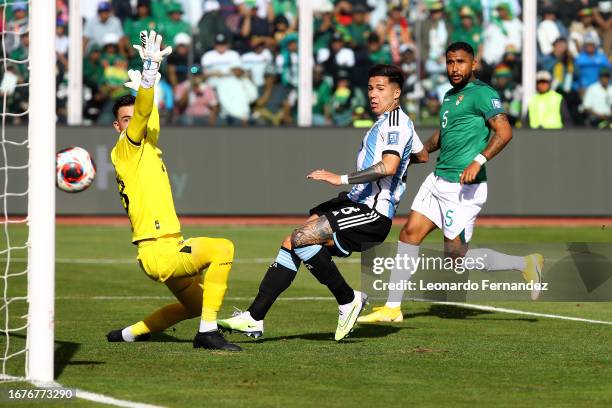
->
[[420, 1, 450, 76]]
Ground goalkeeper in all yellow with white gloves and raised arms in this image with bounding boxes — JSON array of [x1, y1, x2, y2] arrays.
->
[[106, 31, 241, 351]]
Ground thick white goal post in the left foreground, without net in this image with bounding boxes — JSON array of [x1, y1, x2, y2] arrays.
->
[[26, 0, 56, 383]]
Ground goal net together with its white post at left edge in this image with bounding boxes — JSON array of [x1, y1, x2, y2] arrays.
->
[[0, 0, 55, 382]]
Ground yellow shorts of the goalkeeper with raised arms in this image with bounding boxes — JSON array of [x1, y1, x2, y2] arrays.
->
[[137, 234, 233, 282]]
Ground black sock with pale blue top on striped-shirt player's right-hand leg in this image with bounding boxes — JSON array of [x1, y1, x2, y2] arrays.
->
[[294, 245, 355, 305]]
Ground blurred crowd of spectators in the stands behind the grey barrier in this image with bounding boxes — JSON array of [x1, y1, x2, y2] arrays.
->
[[0, 0, 612, 128]]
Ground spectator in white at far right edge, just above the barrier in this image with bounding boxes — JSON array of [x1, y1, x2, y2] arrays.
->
[[582, 69, 612, 129]]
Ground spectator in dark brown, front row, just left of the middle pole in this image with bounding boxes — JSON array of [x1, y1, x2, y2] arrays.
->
[[253, 66, 292, 126]]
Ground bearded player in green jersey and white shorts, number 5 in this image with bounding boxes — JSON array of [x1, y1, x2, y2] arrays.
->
[[357, 42, 544, 323]]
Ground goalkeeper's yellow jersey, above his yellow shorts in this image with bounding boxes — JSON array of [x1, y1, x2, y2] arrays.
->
[[111, 90, 181, 243]]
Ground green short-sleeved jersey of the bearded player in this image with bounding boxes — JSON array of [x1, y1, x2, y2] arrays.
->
[[434, 80, 504, 183]]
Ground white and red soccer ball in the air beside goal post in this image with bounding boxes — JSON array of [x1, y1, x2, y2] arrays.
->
[[55, 147, 96, 193]]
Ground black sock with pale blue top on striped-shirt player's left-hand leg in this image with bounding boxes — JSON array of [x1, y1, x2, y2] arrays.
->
[[247, 247, 301, 320]]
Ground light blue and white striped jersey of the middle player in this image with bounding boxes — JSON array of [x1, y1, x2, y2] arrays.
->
[[348, 107, 423, 218]]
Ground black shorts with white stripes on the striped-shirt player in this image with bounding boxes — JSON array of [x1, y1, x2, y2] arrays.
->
[[310, 192, 391, 257]]
